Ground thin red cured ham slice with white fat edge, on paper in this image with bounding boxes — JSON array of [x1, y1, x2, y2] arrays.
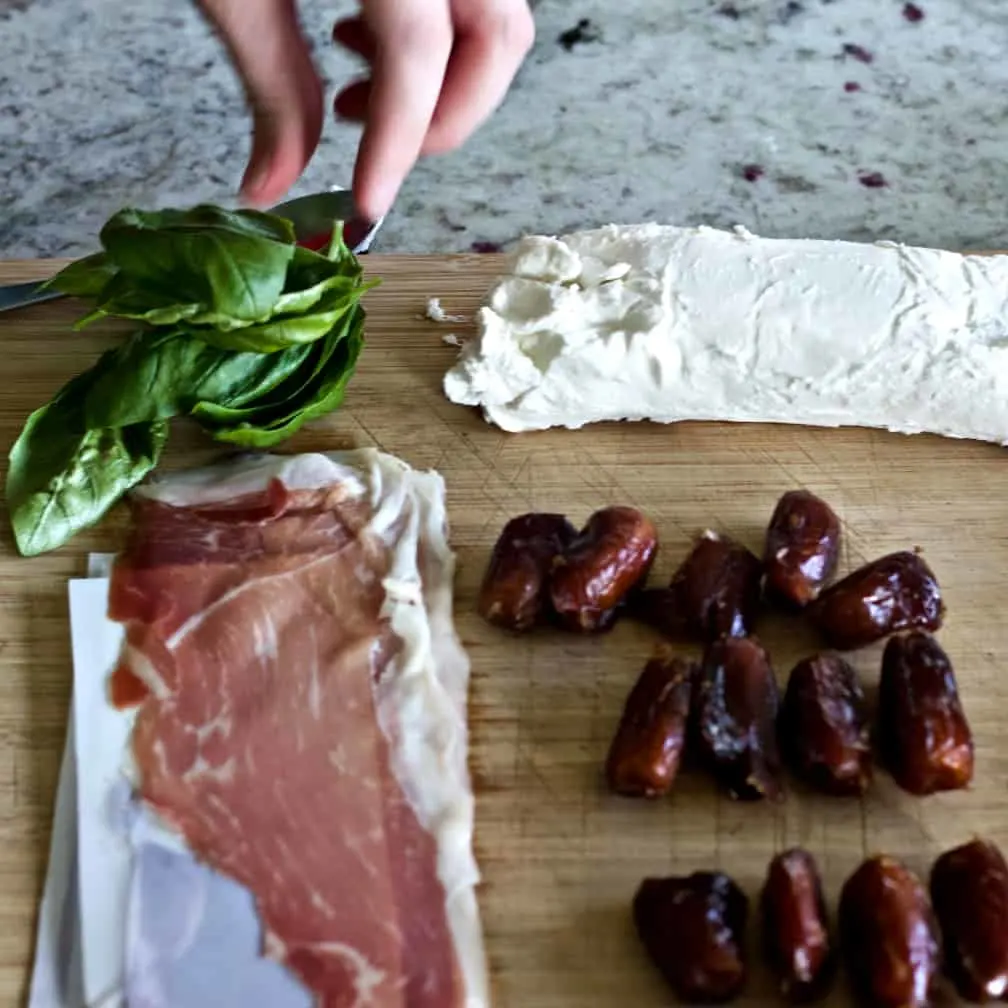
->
[[109, 450, 488, 1008]]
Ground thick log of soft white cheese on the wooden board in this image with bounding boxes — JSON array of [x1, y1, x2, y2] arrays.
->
[[444, 224, 1008, 444]]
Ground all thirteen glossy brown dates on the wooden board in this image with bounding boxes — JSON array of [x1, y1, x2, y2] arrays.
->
[[478, 490, 991, 1008]]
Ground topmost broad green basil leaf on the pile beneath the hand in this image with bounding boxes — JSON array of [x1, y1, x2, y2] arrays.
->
[[98, 207, 295, 328]]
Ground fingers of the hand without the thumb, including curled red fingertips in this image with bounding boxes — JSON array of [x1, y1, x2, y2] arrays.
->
[[333, 0, 535, 221]]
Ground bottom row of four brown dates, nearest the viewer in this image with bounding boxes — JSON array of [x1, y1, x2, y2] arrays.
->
[[633, 839, 1008, 1008]]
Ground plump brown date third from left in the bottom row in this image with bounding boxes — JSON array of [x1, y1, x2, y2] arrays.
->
[[839, 855, 940, 1008]]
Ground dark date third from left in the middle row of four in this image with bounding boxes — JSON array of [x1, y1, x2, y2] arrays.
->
[[777, 654, 872, 795]]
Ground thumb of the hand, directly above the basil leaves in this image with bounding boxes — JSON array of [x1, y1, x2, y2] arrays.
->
[[201, 0, 324, 206]]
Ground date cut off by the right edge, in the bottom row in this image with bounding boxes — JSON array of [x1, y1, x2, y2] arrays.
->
[[931, 840, 1008, 1003]]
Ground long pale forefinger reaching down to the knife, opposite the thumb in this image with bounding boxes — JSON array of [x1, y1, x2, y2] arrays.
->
[[354, 0, 452, 220]]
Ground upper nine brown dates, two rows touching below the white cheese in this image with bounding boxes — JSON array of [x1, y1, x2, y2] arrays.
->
[[479, 490, 974, 799]]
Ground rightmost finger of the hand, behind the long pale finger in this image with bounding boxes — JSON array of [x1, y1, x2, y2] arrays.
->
[[423, 0, 535, 154]]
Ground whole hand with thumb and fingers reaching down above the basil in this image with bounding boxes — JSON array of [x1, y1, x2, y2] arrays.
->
[[192, 0, 534, 220]]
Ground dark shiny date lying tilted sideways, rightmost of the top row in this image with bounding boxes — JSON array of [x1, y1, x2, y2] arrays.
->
[[807, 550, 944, 651]]
